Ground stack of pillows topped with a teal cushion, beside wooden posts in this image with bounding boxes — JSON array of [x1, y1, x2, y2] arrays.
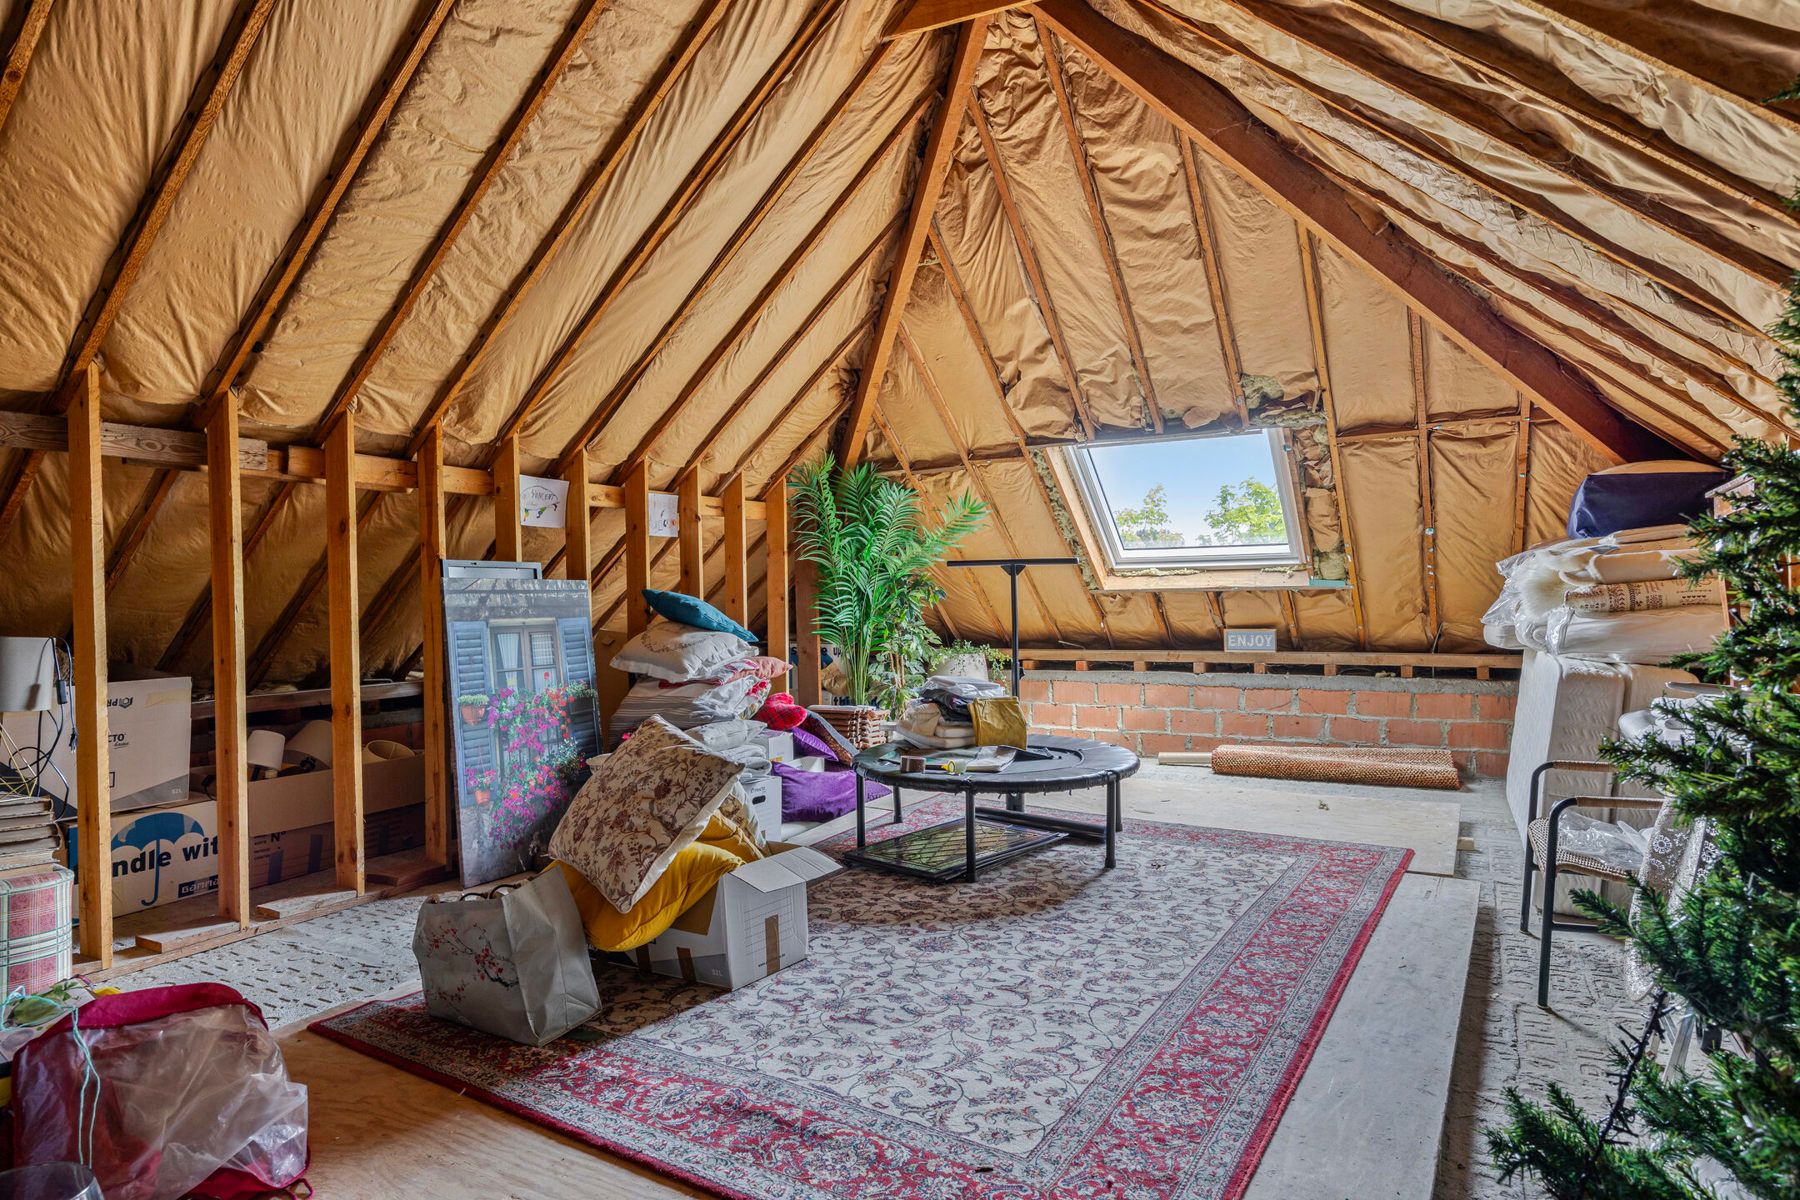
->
[[612, 588, 788, 738]]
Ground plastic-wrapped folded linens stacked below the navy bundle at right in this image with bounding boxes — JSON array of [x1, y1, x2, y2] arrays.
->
[[1481, 525, 1726, 664]]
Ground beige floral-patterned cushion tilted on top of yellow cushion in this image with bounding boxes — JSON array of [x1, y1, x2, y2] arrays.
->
[[551, 716, 740, 912]]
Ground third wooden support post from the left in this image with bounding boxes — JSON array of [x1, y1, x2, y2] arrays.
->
[[326, 417, 364, 896]]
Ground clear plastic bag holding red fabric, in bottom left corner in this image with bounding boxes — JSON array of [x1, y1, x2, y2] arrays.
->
[[13, 984, 308, 1200]]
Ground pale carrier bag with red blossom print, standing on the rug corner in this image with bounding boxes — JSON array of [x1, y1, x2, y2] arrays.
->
[[412, 871, 599, 1045]]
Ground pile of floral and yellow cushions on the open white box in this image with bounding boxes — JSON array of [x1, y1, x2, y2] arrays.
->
[[549, 716, 769, 952]]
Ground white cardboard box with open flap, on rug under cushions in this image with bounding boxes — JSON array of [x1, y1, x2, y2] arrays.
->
[[634, 844, 842, 990]]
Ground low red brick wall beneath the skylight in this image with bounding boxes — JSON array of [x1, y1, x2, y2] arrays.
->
[[1019, 671, 1517, 775]]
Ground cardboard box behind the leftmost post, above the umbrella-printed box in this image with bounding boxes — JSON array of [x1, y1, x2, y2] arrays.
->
[[5, 662, 194, 817]]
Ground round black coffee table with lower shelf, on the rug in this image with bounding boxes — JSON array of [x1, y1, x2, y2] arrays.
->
[[844, 734, 1138, 882]]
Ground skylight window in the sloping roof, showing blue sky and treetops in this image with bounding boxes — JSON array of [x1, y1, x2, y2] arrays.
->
[[1066, 430, 1305, 570]]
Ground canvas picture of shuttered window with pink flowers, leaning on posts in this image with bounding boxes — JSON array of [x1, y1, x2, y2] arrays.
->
[[445, 579, 599, 887]]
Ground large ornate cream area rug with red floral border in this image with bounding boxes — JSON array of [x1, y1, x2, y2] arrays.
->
[[313, 801, 1411, 1200]]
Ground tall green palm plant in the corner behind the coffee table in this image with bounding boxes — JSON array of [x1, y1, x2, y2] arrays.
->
[[788, 453, 988, 703]]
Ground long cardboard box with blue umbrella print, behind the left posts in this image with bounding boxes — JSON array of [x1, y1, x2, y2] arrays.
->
[[101, 756, 425, 916]]
